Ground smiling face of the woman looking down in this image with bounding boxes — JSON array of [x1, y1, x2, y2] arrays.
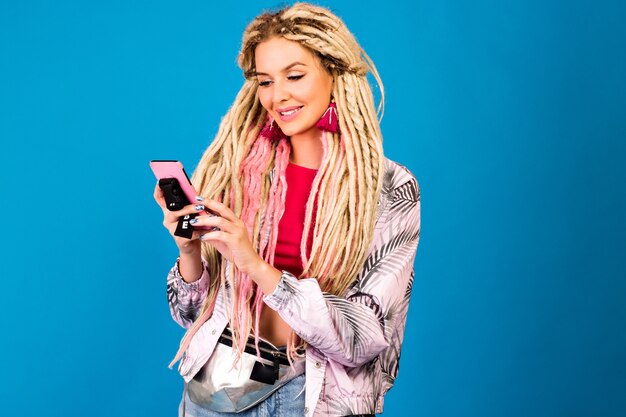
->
[[254, 37, 333, 136]]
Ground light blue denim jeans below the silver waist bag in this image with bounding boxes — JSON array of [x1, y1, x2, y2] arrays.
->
[[178, 374, 305, 417]]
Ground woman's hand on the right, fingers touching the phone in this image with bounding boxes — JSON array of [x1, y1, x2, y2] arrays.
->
[[186, 200, 264, 274]]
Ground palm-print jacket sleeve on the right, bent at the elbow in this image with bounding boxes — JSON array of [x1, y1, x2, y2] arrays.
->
[[264, 176, 420, 367]]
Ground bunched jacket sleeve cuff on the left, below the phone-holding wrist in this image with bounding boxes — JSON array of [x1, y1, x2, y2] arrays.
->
[[167, 258, 209, 329]]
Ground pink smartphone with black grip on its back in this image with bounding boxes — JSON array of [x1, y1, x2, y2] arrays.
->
[[150, 160, 216, 230]]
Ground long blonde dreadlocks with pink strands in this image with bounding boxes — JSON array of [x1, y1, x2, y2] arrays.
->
[[169, 3, 384, 368]]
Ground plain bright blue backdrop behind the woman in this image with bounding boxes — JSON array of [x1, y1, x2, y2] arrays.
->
[[0, 0, 626, 417]]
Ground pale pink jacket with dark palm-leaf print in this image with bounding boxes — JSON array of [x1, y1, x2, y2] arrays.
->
[[167, 158, 420, 417]]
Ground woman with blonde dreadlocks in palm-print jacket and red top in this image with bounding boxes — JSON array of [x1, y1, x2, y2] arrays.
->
[[155, 3, 420, 416]]
